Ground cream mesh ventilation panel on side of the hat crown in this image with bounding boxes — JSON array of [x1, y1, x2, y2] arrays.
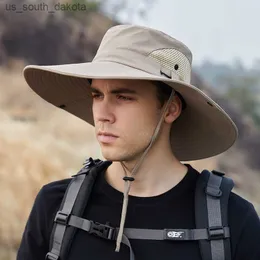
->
[[149, 49, 191, 83]]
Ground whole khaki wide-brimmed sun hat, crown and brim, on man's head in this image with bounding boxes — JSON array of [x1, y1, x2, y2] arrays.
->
[[23, 25, 238, 161]]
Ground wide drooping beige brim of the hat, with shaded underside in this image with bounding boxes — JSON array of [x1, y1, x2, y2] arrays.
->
[[23, 62, 238, 161]]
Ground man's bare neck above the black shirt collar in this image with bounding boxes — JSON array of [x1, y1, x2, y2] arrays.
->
[[105, 148, 188, 197]]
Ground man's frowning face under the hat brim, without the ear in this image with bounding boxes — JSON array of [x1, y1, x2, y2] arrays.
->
[[91, 79, 160, 161]]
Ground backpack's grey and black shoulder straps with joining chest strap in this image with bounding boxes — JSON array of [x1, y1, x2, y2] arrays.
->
[[45, 157, 234, 260]]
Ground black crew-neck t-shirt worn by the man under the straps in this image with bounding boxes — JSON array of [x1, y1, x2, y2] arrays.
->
[[17, 164, 260, 260]]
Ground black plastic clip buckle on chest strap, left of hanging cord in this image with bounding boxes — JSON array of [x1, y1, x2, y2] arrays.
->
[[89, 220, 116, 240]]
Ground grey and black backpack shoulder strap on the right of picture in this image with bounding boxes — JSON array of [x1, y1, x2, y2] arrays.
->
[[195, 170, 234, 260]]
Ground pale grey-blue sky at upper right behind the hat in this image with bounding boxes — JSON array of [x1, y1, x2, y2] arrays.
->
[[115, 0, 260, 67]]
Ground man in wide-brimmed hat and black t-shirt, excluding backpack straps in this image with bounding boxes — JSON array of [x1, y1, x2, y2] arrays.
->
[[17, 25, 260, 260]]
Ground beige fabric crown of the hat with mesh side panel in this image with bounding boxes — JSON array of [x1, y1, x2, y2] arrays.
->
[[93, 25, 192, 83]]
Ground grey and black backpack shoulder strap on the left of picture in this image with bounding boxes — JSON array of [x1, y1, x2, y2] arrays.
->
[[45, 157, 112, 260]]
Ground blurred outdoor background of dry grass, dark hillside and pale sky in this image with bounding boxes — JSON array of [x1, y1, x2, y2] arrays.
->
[[0, 0, 260, 260]]
